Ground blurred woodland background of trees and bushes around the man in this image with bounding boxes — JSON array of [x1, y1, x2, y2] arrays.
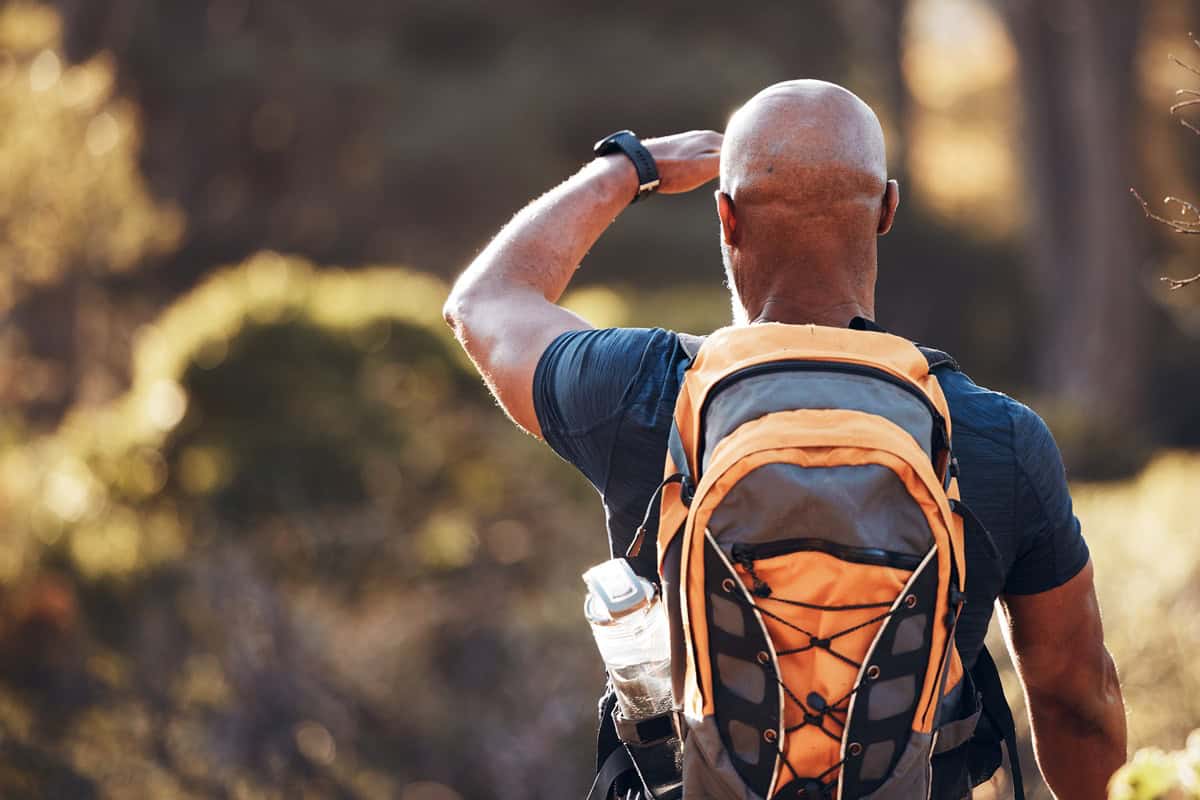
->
[[0, 0, 1200, 800]]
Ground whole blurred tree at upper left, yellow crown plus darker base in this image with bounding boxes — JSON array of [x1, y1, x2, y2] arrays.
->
[[0, 2, 184, 421]]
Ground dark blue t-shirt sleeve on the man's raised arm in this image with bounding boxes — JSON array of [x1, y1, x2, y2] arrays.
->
[[533, 327, 670, 491]]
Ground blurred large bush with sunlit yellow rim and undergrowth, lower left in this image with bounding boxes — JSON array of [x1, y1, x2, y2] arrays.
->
[[0, 253, 604, 798]]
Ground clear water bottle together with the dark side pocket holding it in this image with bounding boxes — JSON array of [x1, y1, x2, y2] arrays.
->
[[583, 559, 683, 800]]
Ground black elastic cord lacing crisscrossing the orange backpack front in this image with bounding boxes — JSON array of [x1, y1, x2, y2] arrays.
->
[[732, 553, 895, 800]]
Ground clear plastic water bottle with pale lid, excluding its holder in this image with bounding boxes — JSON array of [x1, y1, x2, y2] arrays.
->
[[583, 559, 672, 722]]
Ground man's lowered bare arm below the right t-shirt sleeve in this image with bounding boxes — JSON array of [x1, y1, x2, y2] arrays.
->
[[1002, 561, 1126, 800]]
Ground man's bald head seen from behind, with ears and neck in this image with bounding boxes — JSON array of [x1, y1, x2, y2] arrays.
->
[[718, 80, 899, 321]]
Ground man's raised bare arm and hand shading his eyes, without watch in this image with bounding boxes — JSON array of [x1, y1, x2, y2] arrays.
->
[[443, 131, 721, 437]]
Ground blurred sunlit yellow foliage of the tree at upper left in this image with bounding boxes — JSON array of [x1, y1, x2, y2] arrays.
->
[[0, 2, 184, 313]]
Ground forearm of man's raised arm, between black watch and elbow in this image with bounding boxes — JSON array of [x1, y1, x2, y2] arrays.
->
[[454, 155, 637, 302]]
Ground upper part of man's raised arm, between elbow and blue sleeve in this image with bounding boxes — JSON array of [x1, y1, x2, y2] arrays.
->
[[460, 291, 592, 437]]
